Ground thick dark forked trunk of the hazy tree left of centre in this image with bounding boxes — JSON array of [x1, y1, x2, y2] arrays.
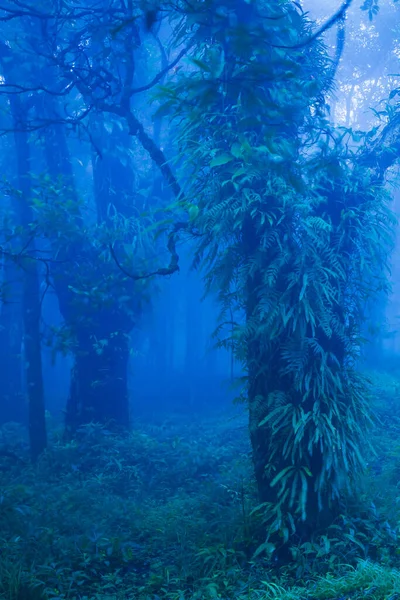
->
[[39, 106, 137, 433]]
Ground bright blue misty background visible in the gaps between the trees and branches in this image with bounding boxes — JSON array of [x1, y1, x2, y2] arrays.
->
[[0, 0, 400, 422]]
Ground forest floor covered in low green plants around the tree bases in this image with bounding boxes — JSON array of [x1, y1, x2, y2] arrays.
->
[[0, 374, 400, 600]]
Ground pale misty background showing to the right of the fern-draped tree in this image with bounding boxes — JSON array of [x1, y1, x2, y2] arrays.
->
[[304, 0, 400, 358]]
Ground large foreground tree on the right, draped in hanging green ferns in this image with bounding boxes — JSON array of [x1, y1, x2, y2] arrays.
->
[[163, 0, 394, 540]]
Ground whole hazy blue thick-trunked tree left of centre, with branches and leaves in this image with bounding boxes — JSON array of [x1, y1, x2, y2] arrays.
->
[[1, 0, 183, 430]]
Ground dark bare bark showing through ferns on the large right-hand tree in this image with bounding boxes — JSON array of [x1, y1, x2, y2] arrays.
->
[[243, 209, 341, 560]]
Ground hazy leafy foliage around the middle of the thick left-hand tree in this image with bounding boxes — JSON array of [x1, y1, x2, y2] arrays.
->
[[6, 176, 159, 353]]
